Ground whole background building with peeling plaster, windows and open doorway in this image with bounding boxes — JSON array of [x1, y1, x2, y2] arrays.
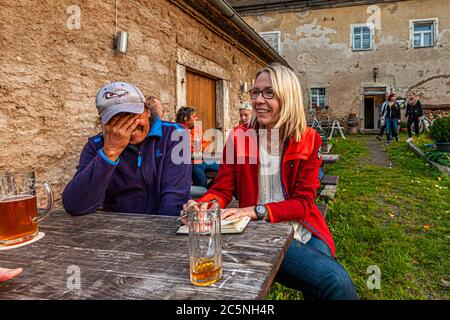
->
[[229, 0, 450, 129]]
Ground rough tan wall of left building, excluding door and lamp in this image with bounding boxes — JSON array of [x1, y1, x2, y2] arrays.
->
[[0, 0, 260, 205]]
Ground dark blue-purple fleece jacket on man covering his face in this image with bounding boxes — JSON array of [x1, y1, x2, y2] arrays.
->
[[62, 118, 192, 216]]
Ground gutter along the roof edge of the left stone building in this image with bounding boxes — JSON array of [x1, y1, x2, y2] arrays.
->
[[209, 0, 291, 68]]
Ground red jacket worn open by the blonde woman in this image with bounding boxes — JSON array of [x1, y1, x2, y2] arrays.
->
[[198, 125, 335, 257]]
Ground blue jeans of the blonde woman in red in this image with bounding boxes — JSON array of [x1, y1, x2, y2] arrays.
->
[[275, 235, 358, 300]]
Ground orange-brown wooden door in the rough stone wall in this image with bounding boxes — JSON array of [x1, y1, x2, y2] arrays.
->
[[186, 70, 216, 132]]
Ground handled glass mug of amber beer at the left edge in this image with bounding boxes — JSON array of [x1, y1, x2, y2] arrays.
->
[[0, 172, 53, 246]]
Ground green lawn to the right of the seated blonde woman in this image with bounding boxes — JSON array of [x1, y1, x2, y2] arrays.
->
[[267, 136, 450, 299]]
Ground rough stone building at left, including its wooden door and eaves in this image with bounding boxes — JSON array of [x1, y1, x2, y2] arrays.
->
[[0, 0, 286, 205]]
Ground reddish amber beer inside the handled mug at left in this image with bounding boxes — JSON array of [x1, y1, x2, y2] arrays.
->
[[0, 195, 38, 245]]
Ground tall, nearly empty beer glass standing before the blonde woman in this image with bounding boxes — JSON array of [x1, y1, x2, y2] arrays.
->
[[186, 201, 222, 286]]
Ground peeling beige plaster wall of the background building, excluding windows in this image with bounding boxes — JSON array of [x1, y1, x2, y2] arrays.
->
[[244, 0, 450, 127]]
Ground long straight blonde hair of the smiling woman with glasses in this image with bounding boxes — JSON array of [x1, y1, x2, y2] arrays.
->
[[252, 63, 307, 142]]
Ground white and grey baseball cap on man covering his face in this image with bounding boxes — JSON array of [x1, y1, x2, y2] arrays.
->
[[95, 82, 145, 124]]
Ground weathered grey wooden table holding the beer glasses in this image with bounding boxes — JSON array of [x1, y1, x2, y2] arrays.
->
[[0, 210, 293, 300]]
